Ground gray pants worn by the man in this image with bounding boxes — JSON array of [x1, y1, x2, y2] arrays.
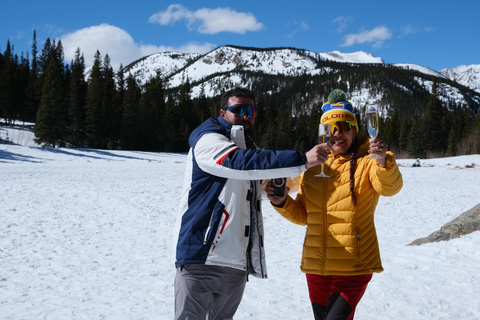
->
[[175, 264, 247, 320]]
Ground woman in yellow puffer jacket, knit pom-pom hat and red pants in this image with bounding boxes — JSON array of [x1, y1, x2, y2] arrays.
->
[[266, 89, 403, 320]]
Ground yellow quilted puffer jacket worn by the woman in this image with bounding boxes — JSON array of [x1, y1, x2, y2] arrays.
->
[[274, 136, 403, 275]]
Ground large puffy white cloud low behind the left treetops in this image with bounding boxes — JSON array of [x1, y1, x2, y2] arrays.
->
[[60, 24, 215, 71]]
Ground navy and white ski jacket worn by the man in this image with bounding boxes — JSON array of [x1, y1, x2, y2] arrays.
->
[[175, 117, 306, 278]]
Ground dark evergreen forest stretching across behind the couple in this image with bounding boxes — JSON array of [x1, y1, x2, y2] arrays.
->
[[0, 32, 480, 158]]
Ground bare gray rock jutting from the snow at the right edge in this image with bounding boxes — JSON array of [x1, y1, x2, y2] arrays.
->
[[409, 204, 480, 246]]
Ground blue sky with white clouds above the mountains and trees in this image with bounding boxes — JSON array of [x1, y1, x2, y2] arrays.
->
[[0, 0, 480, 71]]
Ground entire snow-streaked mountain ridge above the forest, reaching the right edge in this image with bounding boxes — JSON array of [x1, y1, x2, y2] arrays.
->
[[124, 46, 480, 104]]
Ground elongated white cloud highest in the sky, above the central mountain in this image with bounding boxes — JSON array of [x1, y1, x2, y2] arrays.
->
[[148, 4, 263, 34]]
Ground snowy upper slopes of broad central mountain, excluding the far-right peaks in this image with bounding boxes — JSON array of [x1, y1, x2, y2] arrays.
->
[[125, 46, 384, 96]]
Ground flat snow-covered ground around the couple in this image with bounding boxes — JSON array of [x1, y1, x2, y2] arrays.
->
[[0, 127, 480, 320]]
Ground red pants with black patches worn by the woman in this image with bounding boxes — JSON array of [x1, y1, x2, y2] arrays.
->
[[306, 274, 372, 320]]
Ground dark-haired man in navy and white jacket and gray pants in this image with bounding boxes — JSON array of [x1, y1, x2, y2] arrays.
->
[[175, 88, 328, 320]]
